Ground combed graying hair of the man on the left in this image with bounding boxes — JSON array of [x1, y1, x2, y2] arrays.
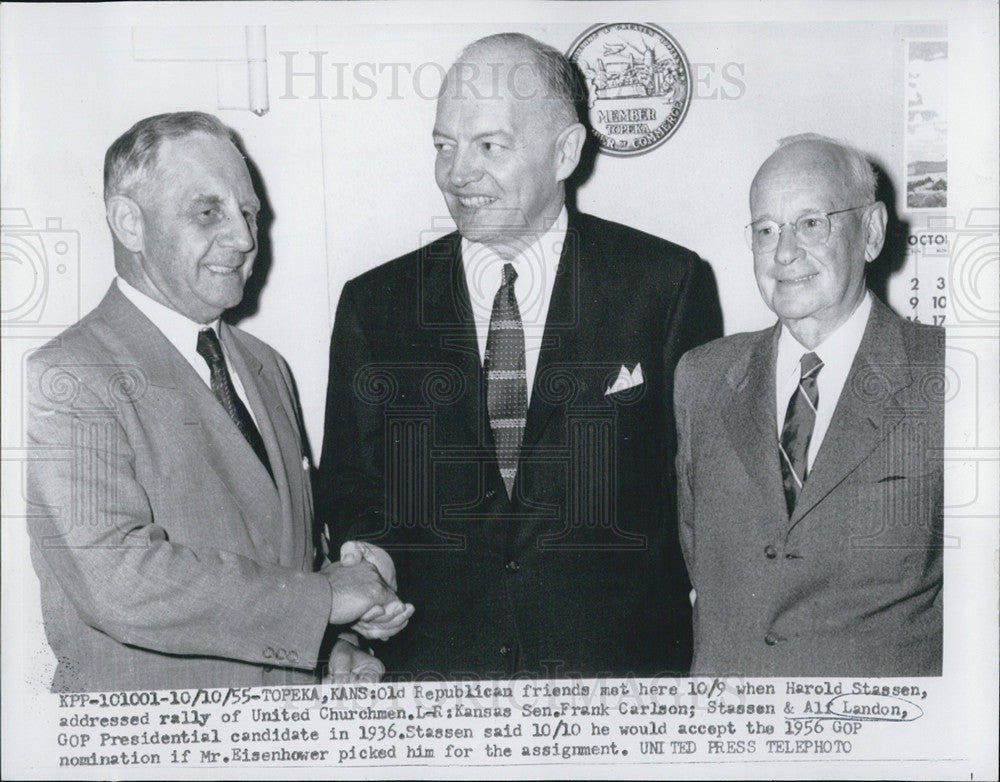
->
[[104, 111, 236, 202]]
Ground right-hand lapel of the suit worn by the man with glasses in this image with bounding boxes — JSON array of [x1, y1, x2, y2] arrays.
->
[[789, 297, 913, 528]]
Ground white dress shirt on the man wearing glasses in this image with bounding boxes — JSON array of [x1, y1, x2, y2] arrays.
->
[[774, 291, 872, 470]]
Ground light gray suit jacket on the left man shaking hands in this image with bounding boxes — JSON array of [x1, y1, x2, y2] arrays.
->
[[27, 284, 331, 691]]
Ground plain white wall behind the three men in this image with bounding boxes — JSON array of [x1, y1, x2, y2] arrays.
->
[[2, 3, 992, 460]]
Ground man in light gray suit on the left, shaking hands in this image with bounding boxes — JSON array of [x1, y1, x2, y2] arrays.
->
[[28, 112, 412, 691]]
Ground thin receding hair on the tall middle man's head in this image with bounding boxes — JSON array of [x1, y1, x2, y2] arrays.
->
[[442, 33, 587, 127]]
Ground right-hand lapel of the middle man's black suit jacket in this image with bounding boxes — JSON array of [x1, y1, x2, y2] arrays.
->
[[522, 215, 618, 448]]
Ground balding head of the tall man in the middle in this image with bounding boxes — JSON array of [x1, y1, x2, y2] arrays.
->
[[434, 33, 586, 257]]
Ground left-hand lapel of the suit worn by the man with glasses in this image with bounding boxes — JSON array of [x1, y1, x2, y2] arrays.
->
[[722, 325, 788, 522]]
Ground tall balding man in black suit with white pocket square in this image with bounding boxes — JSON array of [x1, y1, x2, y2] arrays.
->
[[320, 34, 720, 678]]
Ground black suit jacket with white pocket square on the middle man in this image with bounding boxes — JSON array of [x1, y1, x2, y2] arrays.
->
[[318, 213, 720, 678]]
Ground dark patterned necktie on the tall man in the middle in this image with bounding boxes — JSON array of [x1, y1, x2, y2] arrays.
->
[[484, 263, 528, 496]]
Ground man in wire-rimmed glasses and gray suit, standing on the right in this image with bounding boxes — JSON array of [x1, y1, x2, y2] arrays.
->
[[675, 134, 944, 676]]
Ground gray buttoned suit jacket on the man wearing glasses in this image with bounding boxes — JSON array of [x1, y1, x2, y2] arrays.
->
[[675, 300, 944, 676]]
